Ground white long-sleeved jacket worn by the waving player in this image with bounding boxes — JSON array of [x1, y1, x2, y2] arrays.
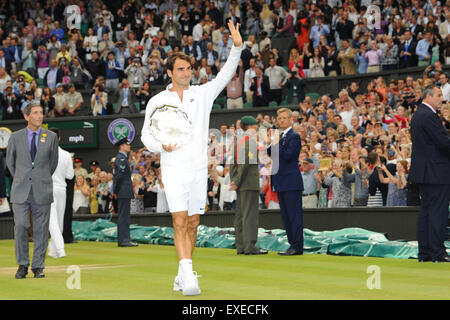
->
[[141, 45, 242, 171]]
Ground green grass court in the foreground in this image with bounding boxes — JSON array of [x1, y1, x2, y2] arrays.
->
[[0, 240, 450, 301]]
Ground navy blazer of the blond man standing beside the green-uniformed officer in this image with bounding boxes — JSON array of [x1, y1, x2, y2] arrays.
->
[[267, 128, 303, 192]]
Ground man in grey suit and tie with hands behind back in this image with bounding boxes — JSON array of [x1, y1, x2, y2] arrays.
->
[[6, 103, 58, 279]]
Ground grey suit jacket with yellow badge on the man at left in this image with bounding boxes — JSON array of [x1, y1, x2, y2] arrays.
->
[[6, 128, 58, 205]]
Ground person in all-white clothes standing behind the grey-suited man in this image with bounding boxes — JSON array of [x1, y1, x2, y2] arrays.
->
[[48, 128, 74, 258]]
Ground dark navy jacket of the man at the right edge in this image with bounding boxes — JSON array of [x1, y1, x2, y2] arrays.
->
[[408, 103, 450, 184]]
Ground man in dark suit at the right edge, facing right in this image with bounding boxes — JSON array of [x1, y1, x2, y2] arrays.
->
[[408, 85, 450, 262]]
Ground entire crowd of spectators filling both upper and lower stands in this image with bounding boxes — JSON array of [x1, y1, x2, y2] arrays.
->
[[0, 0, 450, 212]]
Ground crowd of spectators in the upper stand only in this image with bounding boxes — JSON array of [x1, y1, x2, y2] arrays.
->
[[0, 0, 450, 120]]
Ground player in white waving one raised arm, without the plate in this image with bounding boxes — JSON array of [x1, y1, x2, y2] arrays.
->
[[141, 22, 242, 295]]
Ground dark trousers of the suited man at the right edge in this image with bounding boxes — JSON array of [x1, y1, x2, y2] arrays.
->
[[417, 184, 450, 260]]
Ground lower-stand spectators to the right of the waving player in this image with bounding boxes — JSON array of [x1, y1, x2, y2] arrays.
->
[[208, 76, 450, 210]]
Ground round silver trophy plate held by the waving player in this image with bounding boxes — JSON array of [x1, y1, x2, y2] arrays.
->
[[150, 104, 194, 146]]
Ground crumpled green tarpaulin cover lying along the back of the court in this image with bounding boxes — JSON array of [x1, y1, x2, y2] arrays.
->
[[72, 219, 450, 259]]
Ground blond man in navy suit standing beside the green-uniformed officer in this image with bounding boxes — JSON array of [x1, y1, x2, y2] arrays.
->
[[267, 108, 303, 256]]
